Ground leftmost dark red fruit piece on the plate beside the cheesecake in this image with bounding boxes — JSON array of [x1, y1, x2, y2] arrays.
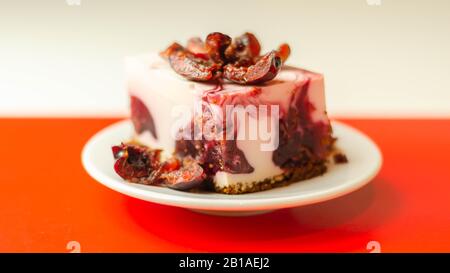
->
[[112, 144, 161, 182]]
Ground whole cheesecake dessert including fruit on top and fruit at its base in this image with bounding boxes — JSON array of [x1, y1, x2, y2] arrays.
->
[[113, 32, 344, 194]]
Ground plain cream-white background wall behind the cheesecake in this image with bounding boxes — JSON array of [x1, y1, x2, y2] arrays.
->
[[0, 0, 450, 117]]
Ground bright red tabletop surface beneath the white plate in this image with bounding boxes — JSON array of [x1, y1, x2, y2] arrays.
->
[[0, 119, 450, 252]]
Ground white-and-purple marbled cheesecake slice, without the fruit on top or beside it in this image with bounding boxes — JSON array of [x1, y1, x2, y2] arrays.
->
[[126, 54, 333, 193]]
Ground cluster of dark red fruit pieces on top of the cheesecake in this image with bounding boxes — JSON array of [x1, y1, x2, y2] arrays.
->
[[161, 32, 290, 84]]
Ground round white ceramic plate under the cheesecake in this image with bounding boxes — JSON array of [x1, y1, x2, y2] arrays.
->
[[82, 120, 382, 216]]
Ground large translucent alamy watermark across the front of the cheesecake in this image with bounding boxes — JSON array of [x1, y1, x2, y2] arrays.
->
[[171, 101, 280, 151]]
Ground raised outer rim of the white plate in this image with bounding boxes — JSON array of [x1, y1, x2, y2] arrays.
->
[[81, 119, 383, 211]]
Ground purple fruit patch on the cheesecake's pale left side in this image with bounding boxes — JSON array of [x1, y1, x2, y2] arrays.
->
[[130, 96, 158, 139]]
